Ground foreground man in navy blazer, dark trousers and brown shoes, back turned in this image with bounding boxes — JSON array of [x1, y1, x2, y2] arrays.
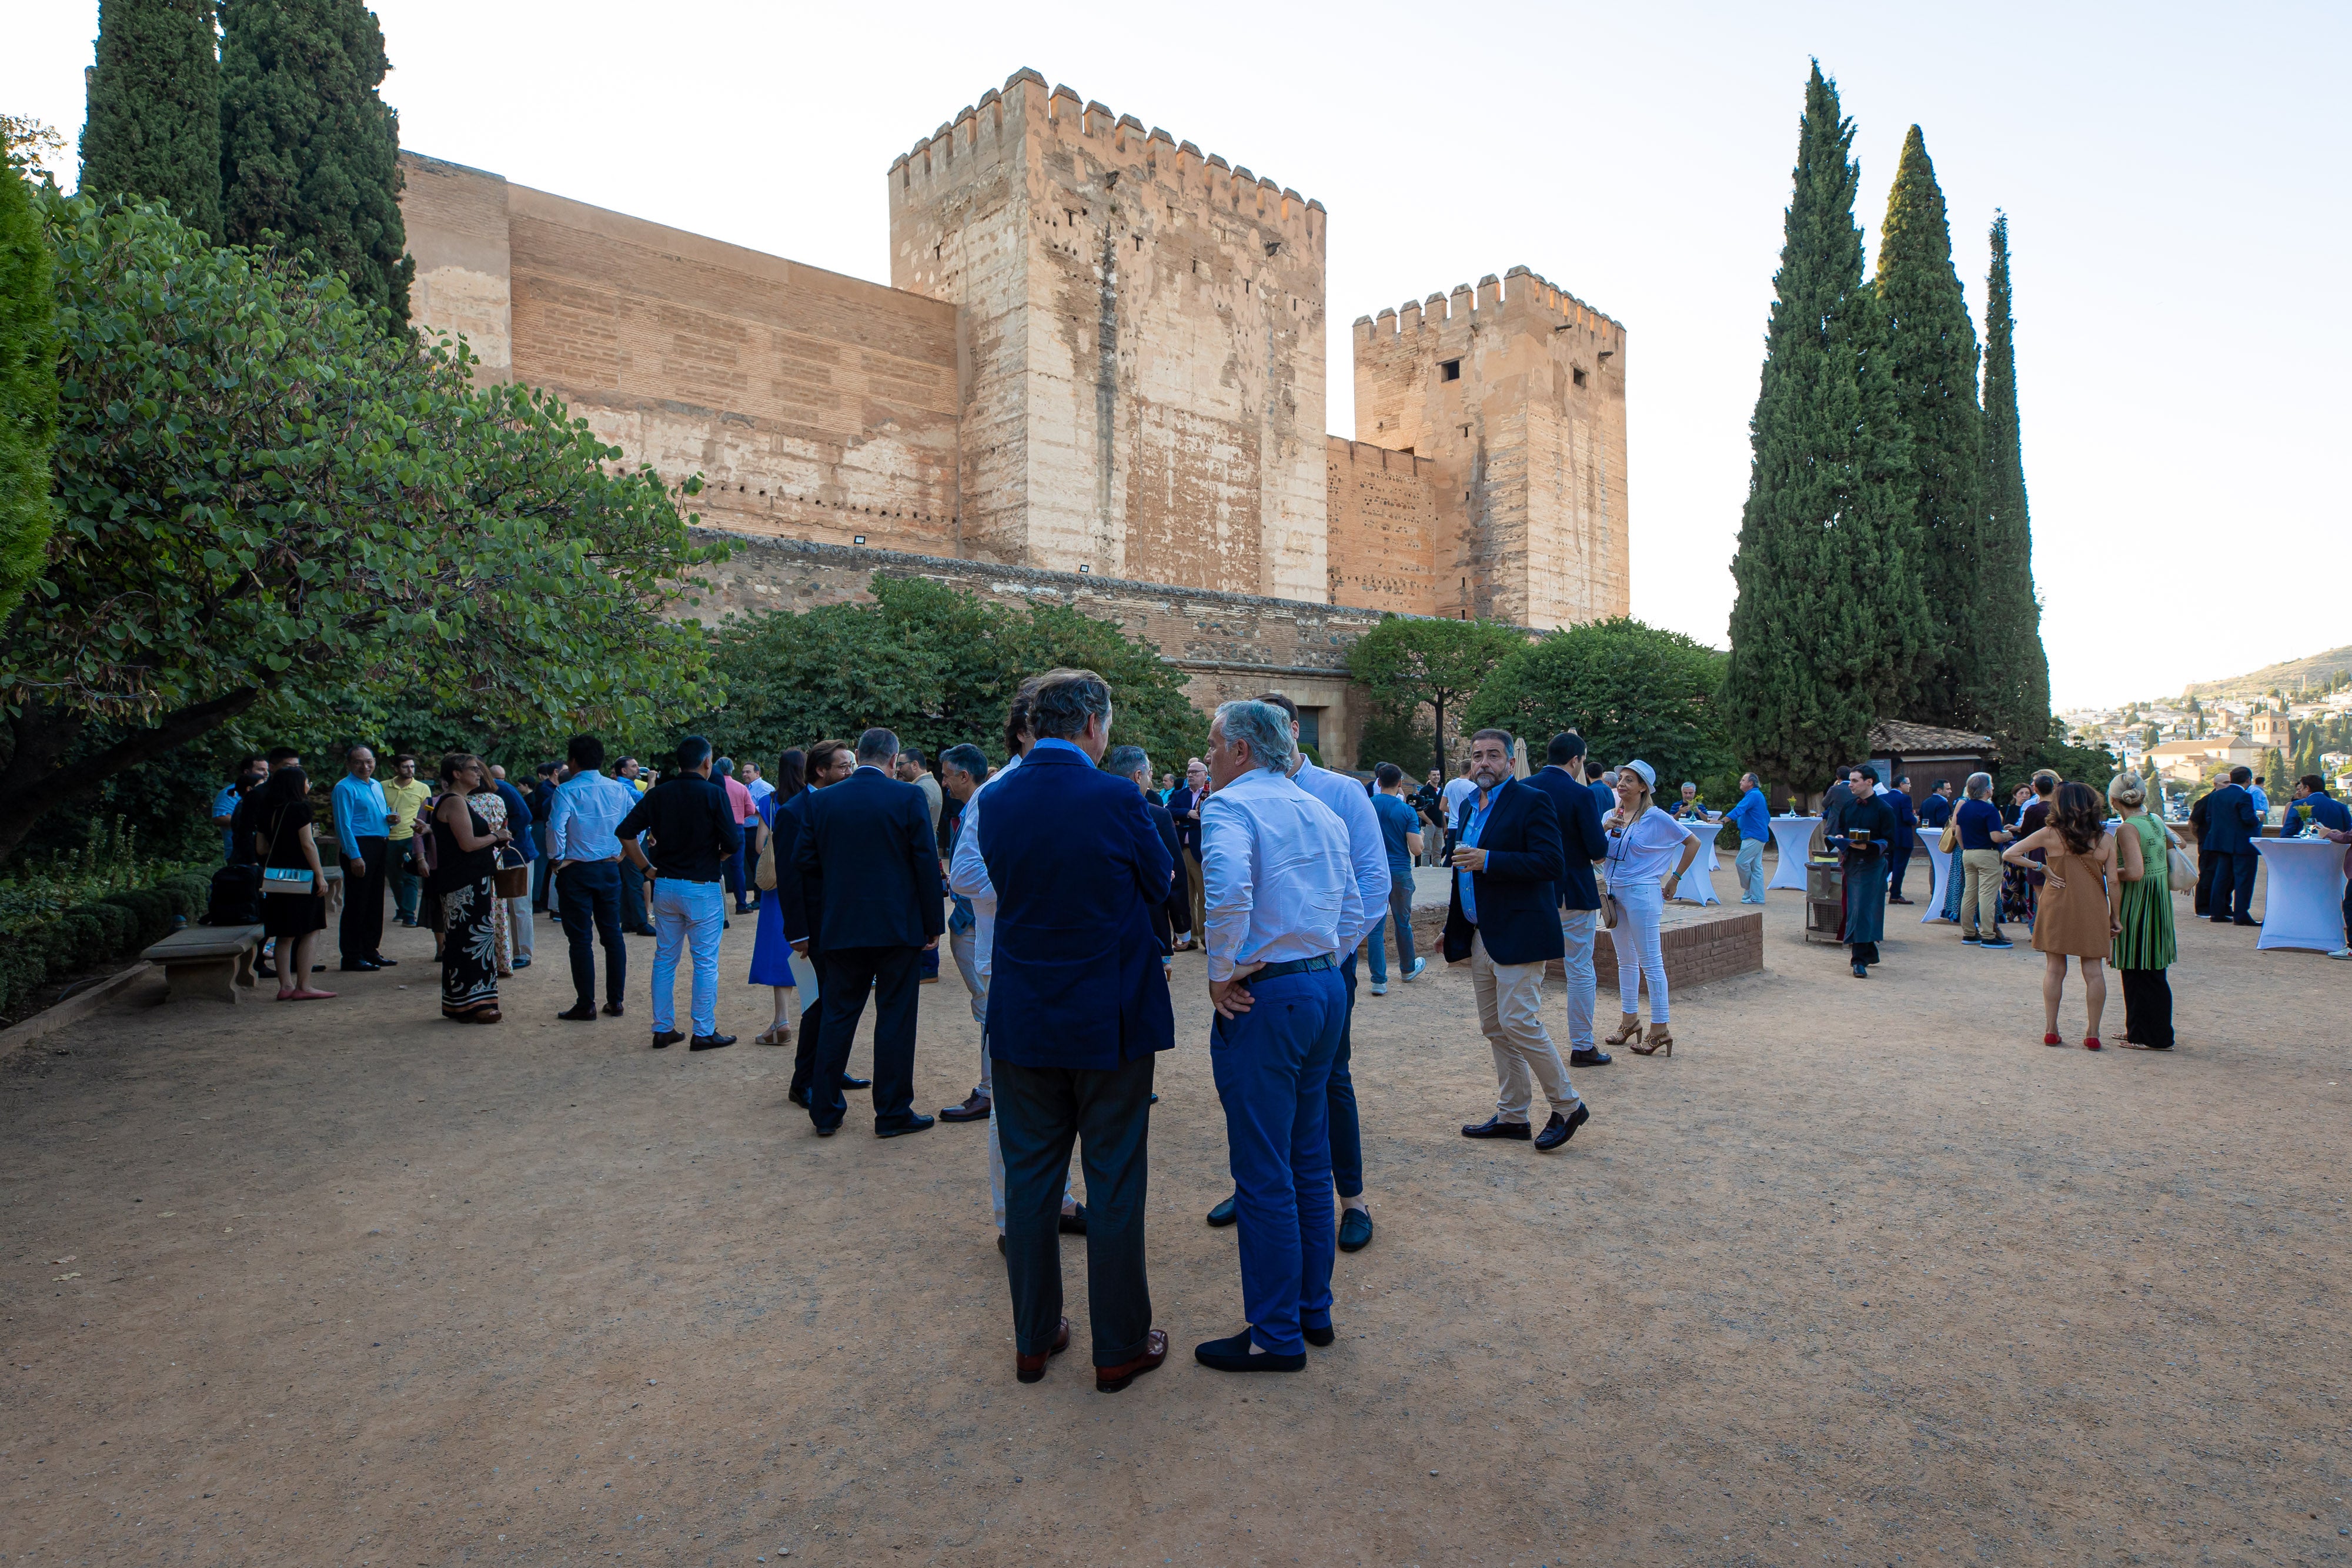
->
[[978, 670, 1176, 1392]]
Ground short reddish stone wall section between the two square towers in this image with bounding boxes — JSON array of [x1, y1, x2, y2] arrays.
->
[[1327, 435, 1461, 616]]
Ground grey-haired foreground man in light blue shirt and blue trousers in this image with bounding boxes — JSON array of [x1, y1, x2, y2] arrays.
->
[[1195, 703, 1364, 1373]]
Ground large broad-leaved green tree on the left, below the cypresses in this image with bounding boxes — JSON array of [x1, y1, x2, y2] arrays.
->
[[0, 195, 720, 858]]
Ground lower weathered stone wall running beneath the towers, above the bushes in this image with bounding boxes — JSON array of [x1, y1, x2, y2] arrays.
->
[[684, 527, 1381, 767]]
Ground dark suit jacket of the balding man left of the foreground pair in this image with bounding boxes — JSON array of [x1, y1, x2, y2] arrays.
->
[[776, 767, 948, 952]]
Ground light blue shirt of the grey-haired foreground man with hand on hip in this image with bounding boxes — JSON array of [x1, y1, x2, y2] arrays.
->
[[1200, 769, 1388, 980]]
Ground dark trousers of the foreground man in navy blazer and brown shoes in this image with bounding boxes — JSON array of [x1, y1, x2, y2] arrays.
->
[[995, 1053, 1152, 1366]]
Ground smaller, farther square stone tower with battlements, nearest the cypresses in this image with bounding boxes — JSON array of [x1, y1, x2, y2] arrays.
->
[[1352, 266, 1632, 630]]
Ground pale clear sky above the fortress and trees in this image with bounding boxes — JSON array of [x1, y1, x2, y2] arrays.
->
[[0, 0, 2352, 708]]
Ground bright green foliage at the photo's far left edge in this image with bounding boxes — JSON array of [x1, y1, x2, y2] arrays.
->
[[0, 158, 56, 616]]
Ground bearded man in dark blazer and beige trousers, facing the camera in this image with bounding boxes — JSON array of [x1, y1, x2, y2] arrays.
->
[[1444, 729, 1592, 1149]]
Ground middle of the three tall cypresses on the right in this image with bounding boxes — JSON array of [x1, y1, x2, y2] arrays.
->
[[1877, 125, 1985, 727]]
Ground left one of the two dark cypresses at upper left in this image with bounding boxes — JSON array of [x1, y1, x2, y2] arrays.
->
[[82, 0, 221, 240]]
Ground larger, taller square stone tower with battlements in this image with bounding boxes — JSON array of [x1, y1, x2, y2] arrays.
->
[[889, 71, 1329, 602]]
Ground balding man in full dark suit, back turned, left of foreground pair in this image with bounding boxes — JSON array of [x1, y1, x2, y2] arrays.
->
[[793, 729, 948, 1138]]
